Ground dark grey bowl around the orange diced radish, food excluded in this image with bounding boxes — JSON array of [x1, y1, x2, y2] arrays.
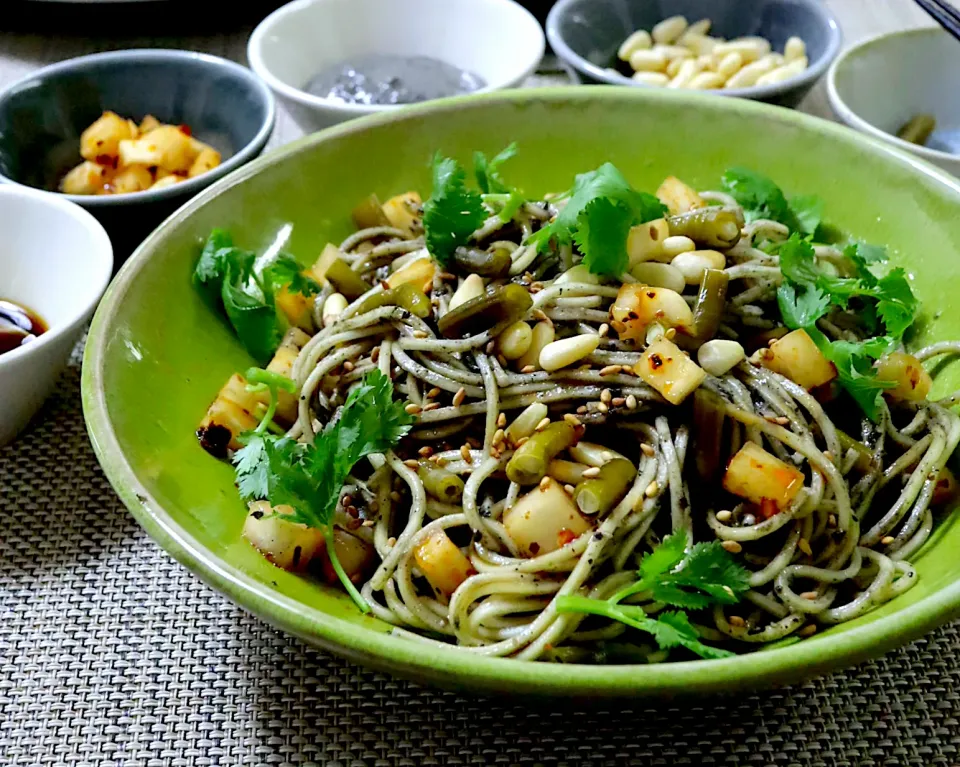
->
[[0, 50, 276, 265]]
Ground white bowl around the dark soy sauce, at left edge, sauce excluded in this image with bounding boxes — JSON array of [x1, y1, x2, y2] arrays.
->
[[0, 186, 113, 445]]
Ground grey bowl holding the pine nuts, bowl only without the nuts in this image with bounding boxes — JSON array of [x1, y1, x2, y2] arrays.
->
[[547, 0, 842, 107]]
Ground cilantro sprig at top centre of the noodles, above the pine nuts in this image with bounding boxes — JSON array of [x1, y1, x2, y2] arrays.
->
[[527, 163, 667, 277]]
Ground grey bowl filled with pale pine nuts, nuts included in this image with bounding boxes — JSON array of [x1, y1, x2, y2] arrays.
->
[[547, 0, 842, 107]]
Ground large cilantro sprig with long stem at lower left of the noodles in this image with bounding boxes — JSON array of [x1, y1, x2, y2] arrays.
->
[[233, 370, 413, 612]]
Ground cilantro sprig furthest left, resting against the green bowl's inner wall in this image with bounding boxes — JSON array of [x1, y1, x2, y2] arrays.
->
[[193, 229, 320, 365]]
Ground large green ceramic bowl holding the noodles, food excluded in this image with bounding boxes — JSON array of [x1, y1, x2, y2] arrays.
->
[[83, 87, 960, 700]]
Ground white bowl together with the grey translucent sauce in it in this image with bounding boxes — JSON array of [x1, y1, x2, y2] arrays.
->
[[247, 0, 544, 132]]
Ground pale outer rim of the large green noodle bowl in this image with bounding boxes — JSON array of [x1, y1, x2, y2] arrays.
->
[[82, 86, 960, 700]]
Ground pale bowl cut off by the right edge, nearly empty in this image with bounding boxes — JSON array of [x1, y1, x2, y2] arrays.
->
[[827, 27, 960, 176]]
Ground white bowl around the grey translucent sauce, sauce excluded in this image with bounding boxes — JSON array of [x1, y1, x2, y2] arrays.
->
[[247, 0, 544, 132]]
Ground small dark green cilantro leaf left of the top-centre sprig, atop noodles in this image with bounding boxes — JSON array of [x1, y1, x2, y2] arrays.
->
[[423, 152, 487, 266]]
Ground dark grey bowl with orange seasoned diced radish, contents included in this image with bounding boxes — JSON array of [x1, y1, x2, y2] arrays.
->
[[0, 50, 275, 262]]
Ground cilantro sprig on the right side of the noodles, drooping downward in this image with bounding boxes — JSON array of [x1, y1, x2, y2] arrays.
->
[[777, 234, 919, 421]]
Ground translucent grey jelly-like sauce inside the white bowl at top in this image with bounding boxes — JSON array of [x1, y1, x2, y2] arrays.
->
[[306, 53, 486, 105]]
